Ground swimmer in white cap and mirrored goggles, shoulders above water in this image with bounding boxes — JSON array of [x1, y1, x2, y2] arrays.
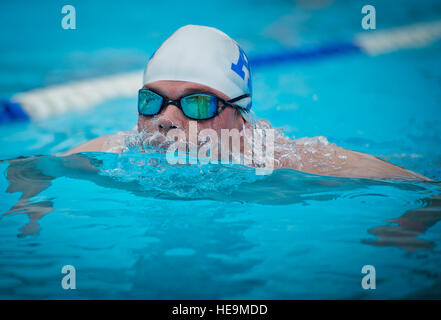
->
[[61, 25, 430, 181]]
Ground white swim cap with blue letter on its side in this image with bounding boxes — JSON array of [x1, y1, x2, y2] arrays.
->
[[143, 25, 252, 110]]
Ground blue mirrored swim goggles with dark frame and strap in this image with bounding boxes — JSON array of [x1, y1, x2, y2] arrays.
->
[[138, 89, 250, 120]]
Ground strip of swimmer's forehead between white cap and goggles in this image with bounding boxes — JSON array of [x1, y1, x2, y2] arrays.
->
[[143, 80, 230, 100]]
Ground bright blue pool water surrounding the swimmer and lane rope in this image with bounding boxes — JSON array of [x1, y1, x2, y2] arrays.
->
[[0, 0, 441, 299]]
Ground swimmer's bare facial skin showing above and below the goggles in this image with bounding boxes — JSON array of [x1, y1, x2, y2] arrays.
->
[[138, 80, 244, 136]]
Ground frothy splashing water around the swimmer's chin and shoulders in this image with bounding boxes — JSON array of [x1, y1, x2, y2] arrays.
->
[[102, 116, 347, 179]]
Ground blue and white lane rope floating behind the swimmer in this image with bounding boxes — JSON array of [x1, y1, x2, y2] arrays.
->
[[0, 20, 441, 124]]
